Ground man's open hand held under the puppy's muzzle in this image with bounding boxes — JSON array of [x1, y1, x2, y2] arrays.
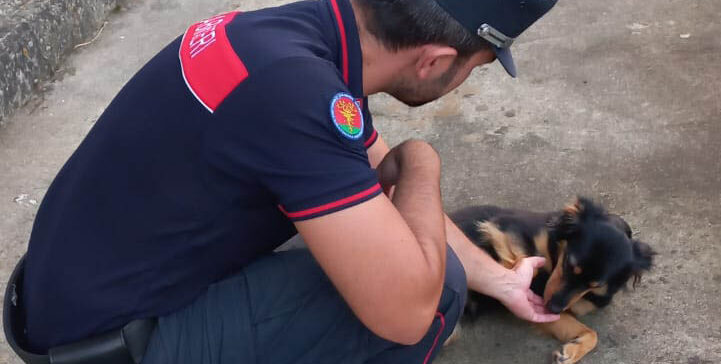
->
[[495, 257, 560, 322]]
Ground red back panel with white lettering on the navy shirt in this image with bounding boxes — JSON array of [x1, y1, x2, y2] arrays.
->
[[179, 12, 248, 113]]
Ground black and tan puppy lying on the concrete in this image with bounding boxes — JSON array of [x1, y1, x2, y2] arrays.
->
[[451, 198, 655, 364]]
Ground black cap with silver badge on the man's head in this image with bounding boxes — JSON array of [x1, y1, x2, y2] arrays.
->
[[436, 0, 557, 77]]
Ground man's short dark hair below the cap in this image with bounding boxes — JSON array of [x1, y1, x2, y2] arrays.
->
[[353, 0, 490, 58]]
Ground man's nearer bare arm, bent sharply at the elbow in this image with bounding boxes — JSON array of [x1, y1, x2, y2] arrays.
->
[[296, 141, 446, 344]]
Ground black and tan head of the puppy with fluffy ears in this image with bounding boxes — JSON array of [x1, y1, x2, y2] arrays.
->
[[543, 197, 655, 313]]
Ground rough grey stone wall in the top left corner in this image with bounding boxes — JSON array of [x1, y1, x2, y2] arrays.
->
[[0, 0, 136, 122]]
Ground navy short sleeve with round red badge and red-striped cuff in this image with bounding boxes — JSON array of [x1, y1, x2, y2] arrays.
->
[[205, 57, 381, 221]]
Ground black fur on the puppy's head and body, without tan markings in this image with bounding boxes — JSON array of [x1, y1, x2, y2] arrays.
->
[[451, 197, 655, 318]]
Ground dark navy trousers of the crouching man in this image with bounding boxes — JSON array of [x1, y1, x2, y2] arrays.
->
[[143, 248, 466, 364]]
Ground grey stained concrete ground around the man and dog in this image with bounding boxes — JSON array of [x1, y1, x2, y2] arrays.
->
[[0, 0, 721, 364]]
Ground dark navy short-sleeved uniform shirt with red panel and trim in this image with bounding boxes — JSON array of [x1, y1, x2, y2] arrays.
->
[[24, 0, 381, 350]]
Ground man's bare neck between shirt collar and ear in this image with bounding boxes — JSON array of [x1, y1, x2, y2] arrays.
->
[[351, 1, 413, 96]]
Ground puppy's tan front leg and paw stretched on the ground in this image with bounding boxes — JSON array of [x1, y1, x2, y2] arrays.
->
[[538, 313, 598, 364]]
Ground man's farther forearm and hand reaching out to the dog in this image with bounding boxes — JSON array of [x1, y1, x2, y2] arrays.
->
[[368, 136, 559, 322]]
